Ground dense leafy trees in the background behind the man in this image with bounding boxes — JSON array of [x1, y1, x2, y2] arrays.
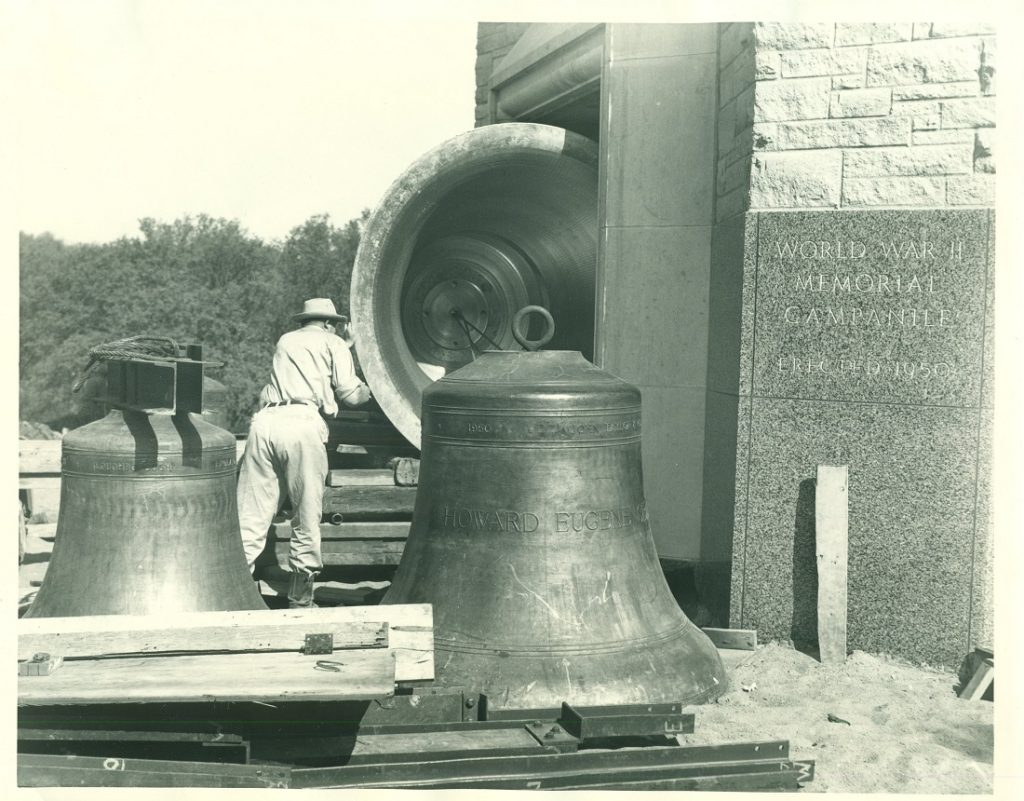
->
[[18, 212, 368, 432]]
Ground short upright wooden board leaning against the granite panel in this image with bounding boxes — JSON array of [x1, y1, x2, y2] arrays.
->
[[814, 465, 849, 665]]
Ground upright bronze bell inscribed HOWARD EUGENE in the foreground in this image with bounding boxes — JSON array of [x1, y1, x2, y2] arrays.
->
[[384, 342, 726, 709]]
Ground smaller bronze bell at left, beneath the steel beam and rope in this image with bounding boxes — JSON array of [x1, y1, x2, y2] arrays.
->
[[26, 409, 266, 618]]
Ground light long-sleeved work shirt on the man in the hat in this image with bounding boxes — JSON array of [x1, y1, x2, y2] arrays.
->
[[260, 326, 362, 417]]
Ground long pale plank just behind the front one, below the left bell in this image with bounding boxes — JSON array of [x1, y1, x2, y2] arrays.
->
[[15, 603, 434, 681]]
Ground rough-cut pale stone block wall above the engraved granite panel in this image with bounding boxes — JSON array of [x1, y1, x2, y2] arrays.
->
[[737, 23, 995, 213]]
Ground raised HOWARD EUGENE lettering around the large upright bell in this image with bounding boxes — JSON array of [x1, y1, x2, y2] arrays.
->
[[433, 503, 648, 534]]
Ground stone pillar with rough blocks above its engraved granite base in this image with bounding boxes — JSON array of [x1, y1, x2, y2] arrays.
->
[[701, 23, 997, 666]]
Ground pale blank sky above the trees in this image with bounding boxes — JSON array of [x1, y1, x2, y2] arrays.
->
[[12, 0, 476, 243]]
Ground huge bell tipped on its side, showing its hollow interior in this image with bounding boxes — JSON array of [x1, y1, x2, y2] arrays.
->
[[351, 123, 599, 447]]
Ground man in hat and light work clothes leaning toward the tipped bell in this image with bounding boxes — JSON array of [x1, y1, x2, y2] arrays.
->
[[238, 298, 370, 607]]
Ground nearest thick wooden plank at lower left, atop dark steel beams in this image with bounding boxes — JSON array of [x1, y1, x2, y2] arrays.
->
[[17, 648, 395, 705]]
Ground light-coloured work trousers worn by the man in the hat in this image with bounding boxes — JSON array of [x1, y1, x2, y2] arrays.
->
[[238, 405, 328, 573]]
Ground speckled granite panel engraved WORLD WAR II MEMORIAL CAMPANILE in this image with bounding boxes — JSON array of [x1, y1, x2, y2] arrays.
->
[[730, 210, 991, 665]]
